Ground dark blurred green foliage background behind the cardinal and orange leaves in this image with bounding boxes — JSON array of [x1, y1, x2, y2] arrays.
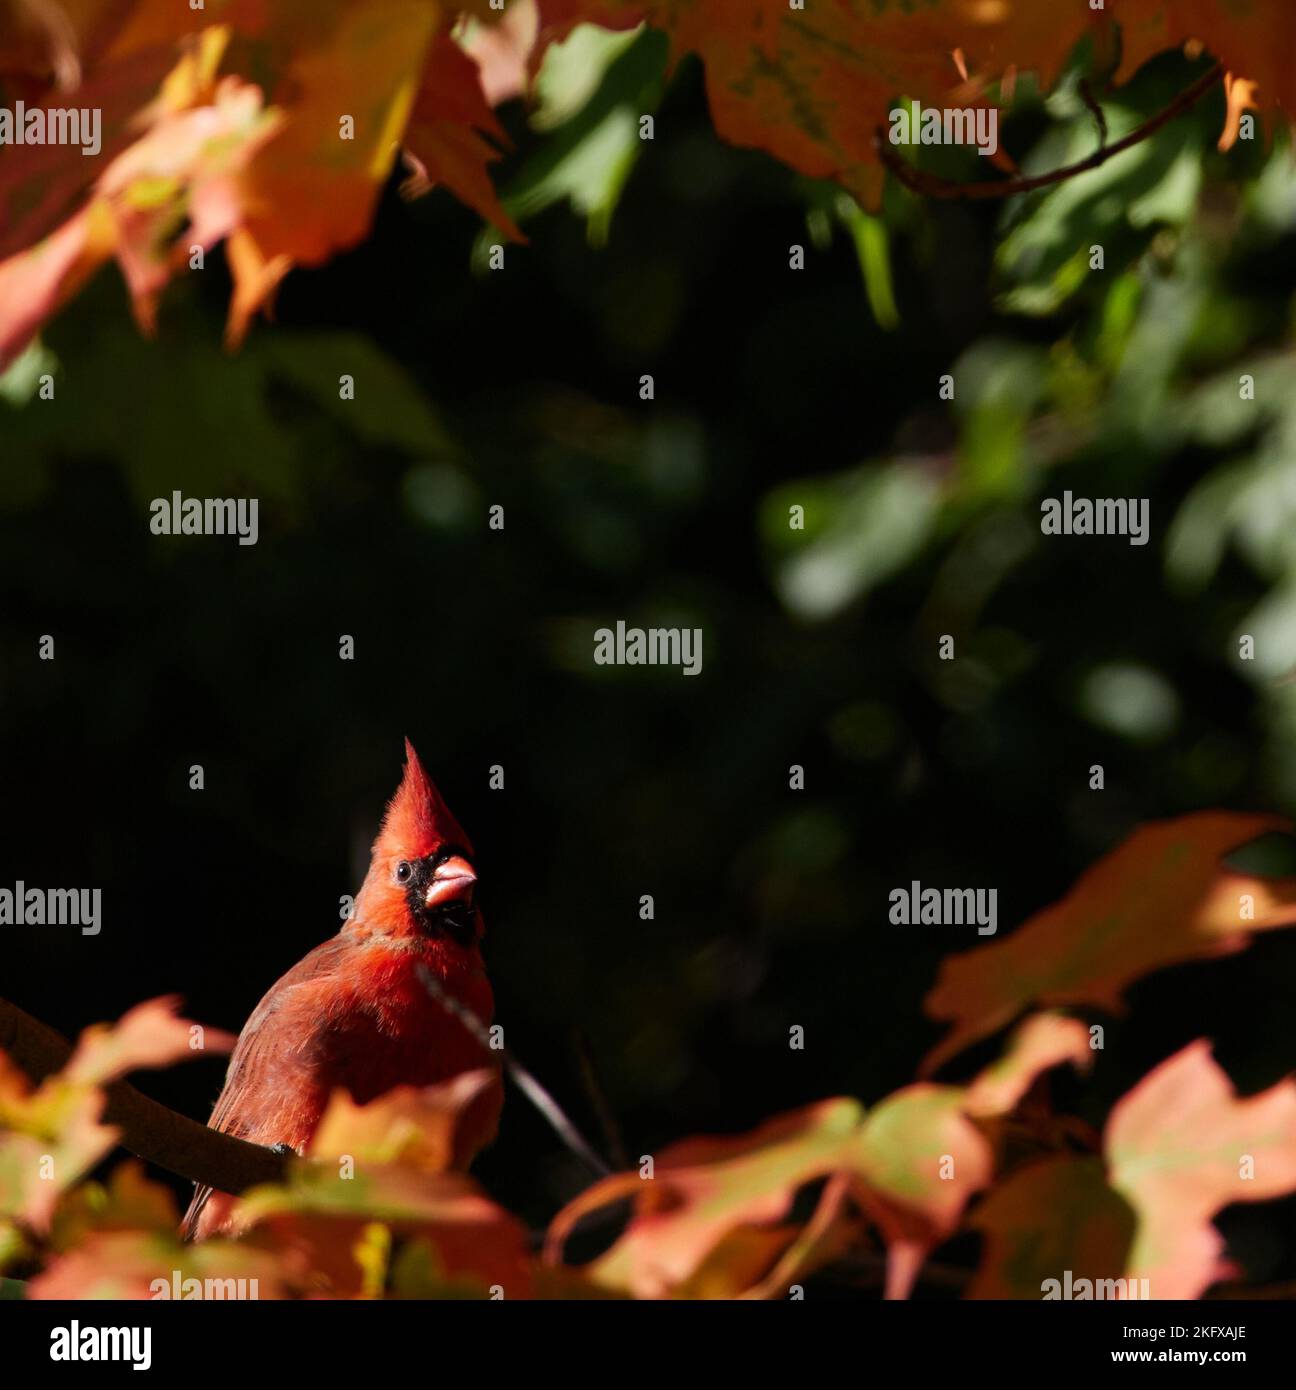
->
[[0, 31, 1296, 1282]]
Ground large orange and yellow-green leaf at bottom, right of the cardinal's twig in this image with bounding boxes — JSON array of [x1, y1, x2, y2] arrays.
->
[[546, 1016, 1089, 1298]]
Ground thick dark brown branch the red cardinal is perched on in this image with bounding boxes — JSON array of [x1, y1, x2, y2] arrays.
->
[[0, 999, 288, 1195]]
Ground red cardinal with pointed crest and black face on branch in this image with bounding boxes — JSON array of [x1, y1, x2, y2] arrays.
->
[[182, 739, 503, 1238]]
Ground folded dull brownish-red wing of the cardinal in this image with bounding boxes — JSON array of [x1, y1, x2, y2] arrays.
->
[[181, 935, 355, 1240]]
